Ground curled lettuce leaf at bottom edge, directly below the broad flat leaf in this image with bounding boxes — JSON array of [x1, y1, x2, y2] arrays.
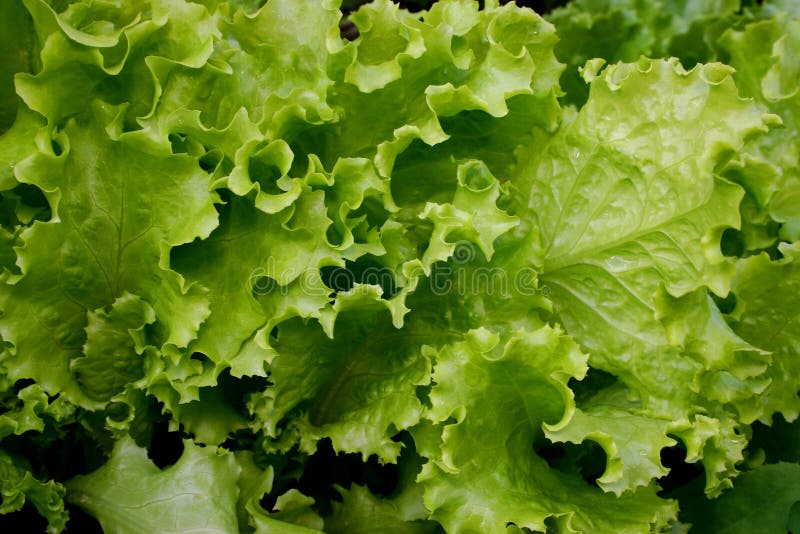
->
[[413, 326, 676, 533]]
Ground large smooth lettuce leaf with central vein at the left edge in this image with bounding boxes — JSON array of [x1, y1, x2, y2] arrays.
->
[[0, 100, 217, 405]]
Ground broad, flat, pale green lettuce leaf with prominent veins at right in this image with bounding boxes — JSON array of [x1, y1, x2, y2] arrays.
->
[[518, 61, 763, 408]]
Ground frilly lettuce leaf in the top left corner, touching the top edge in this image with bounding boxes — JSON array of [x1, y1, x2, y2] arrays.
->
[[16, 0, 221, 129]]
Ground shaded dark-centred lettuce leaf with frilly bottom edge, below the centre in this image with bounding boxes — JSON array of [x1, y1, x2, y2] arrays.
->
[[251, 285, 434, 462]]
